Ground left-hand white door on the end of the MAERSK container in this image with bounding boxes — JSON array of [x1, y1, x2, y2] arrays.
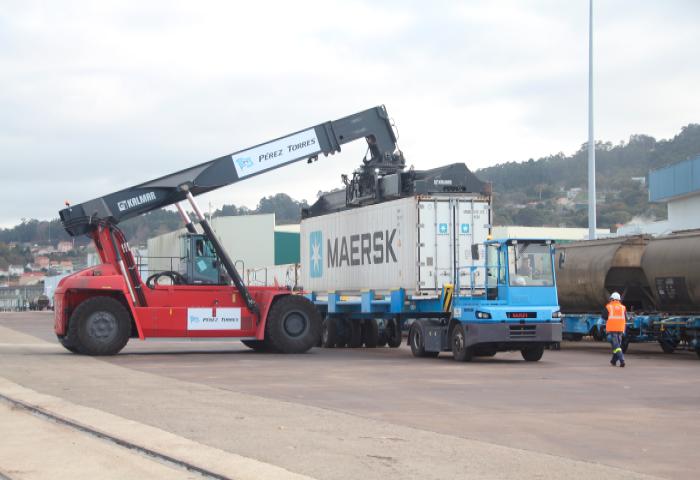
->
[[418, 200, 454, 290]]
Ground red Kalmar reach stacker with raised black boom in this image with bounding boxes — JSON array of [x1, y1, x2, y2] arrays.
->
[[54, 106, 405, 355]]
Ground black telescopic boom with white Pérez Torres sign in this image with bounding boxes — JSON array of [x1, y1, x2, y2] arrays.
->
[[59, 106, 405, 236]]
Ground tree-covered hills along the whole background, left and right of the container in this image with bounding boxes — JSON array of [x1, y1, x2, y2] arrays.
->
[[5, 124, 700, 245]]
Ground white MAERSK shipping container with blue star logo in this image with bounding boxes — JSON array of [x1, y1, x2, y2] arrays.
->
[[301, 194, 490, 294]]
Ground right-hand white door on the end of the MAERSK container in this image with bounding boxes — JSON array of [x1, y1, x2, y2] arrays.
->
[[454, 200, 489, 290]]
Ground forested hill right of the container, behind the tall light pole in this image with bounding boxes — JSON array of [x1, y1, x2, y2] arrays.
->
[[476, 124, 700, 228]]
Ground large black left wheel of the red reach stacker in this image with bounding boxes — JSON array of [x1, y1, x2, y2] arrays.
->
[[66, 297, 131, 356]]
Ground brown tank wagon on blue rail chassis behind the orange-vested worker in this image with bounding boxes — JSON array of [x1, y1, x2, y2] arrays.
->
[[555, 230, 700, 356]]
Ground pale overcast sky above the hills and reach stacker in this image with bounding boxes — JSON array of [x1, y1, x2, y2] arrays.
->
[[0, 0, 700, 226]]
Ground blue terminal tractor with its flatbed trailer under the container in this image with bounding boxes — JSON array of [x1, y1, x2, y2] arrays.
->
[[308, 239, 562, 361]]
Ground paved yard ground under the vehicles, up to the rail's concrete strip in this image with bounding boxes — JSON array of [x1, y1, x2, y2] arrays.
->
[[0, 313, 700, 478]]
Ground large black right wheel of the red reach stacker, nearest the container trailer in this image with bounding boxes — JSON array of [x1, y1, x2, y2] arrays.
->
[[265, 295, 321, 353]]
